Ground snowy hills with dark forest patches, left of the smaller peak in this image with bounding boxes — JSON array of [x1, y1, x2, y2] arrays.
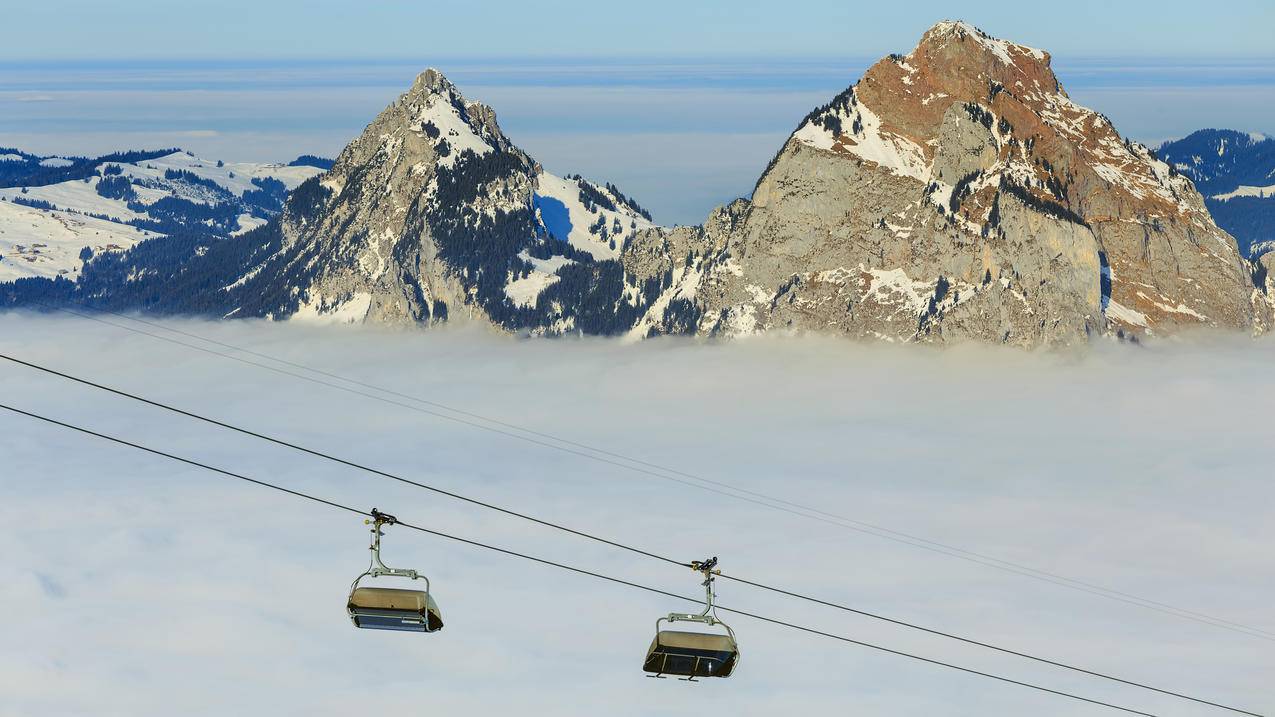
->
[[0, 149, 323, 282]]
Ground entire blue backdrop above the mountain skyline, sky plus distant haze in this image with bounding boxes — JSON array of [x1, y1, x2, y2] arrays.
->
[[0, 0, 1275, 225]]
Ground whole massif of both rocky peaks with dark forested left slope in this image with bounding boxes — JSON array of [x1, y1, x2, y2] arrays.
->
[[0, 22, 1275, 346]]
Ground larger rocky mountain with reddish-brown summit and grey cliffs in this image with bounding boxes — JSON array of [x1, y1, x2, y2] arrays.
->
[[647, 22, 1266, 346]]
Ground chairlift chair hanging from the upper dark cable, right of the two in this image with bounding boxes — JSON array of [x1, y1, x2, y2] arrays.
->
[[643, 558, 740, 681]]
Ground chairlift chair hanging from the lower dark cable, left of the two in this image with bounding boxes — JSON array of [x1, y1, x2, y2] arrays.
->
[[346, 508, 442, 633]]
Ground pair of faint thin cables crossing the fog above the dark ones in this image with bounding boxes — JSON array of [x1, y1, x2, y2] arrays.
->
[[17, 304, 1275, 642]]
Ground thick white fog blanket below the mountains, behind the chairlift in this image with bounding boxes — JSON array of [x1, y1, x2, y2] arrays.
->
[[0, 314, 1275, 717]]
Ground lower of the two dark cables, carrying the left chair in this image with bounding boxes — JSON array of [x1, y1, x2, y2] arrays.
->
[[0, 403, 1173, 717]]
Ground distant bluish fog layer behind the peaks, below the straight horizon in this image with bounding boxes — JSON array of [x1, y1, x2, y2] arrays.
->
[[0, 55, 1275, 225]]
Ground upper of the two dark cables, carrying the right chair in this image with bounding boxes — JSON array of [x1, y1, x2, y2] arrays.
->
[[0, 353, 1261, 717]]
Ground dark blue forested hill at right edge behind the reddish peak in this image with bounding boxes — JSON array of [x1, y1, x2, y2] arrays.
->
[[1159, 129, 1275, 256]]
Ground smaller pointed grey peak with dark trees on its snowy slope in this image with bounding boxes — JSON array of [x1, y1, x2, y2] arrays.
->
[[156, 69, 652, 332]]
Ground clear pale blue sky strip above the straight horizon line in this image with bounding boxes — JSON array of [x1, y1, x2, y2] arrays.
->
[[7, 0, 1275, 60]]
